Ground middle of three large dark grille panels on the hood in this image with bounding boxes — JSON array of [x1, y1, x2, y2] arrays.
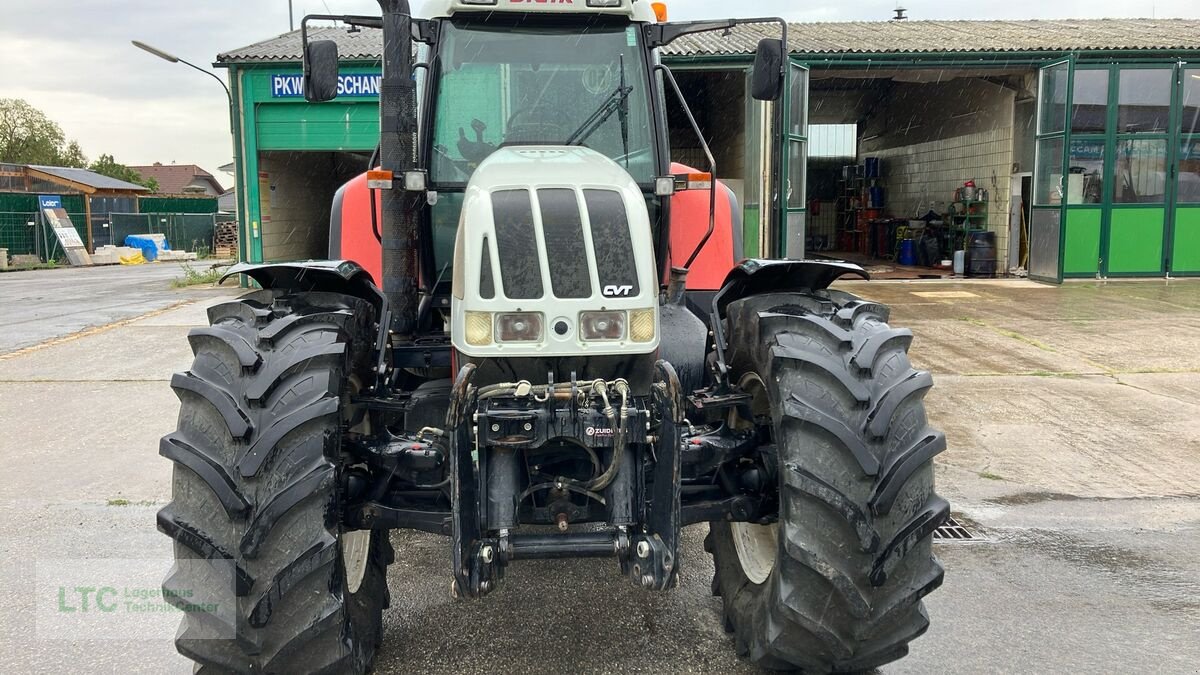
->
[[538, 189, 592, 298]]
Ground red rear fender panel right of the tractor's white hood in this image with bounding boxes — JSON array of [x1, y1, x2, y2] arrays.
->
[[671, 163, 742, 291]]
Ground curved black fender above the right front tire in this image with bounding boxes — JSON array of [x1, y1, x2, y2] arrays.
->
[[709, 258, 871, 388]]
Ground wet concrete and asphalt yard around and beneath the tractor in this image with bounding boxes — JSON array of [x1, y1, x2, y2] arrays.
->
[[0, 270, 1200, 674]]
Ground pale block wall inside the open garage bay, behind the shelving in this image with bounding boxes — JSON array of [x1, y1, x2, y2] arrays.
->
[[872, 126, 1013, 270]]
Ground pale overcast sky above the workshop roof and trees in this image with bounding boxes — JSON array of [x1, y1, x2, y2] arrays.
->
[[0, 0, 1200, 184]]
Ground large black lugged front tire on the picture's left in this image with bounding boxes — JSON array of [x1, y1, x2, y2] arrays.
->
[[158, 291, 392, 673]]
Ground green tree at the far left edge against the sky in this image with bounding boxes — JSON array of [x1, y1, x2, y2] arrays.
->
[[0, 98, 88, 167]]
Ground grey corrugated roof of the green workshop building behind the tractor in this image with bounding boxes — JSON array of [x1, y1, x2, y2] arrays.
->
[[217, 19, 1200, 64]]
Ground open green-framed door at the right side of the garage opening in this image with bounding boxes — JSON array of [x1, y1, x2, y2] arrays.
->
[[1030, 54, 1075, 283]]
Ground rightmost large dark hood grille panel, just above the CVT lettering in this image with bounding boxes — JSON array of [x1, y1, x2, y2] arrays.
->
[[583, 190, 641, 298]]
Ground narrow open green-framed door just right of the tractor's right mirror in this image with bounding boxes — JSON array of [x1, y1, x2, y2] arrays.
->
[[772, 59, 809, 258]]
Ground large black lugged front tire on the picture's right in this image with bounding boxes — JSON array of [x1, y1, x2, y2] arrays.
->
[[706, 291, 949, 673]]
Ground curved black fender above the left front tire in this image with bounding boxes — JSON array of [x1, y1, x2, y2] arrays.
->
[[221, 261, 388, 316]]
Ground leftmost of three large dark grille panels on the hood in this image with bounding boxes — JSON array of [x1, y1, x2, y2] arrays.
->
[[492, 190, 542, 300]]
